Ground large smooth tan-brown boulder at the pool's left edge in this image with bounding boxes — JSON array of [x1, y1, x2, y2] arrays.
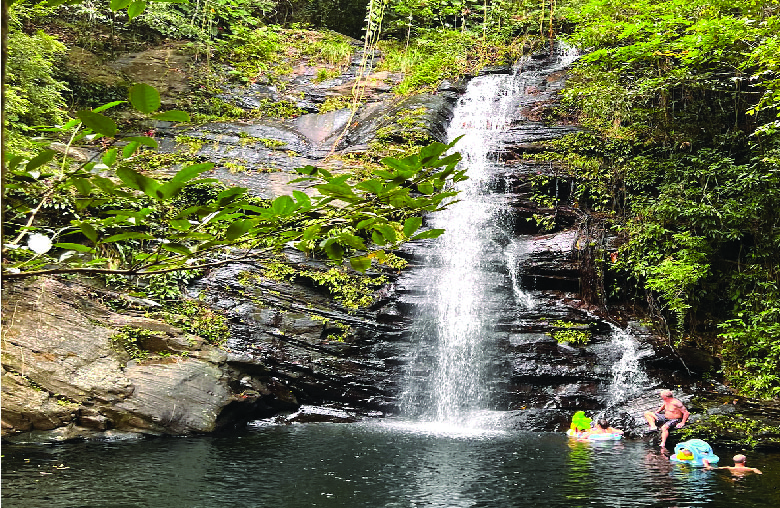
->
[[2, 278, 297, 439]]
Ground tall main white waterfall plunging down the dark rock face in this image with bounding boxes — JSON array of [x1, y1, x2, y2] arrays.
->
[[402, 45, 575, 427]]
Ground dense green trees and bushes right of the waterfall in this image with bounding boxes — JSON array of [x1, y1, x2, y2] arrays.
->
[[554, 0, 780, 397]]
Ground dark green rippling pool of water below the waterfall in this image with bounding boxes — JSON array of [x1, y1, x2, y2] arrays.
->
[[2, 422, 780, 508]]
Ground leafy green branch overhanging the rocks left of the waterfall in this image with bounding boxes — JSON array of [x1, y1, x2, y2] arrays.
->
[[3, 76, 465, 278]]
